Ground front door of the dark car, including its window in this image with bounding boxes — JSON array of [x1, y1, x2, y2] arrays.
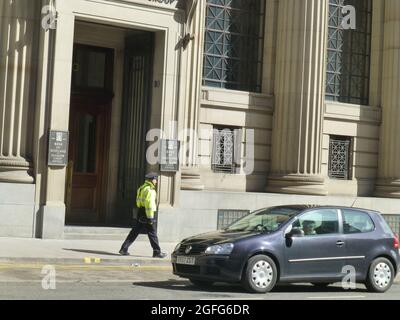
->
[[285, 208, 345, 280]]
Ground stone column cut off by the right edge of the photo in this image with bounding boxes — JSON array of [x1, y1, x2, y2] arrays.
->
[[375, 0, 400, 198]]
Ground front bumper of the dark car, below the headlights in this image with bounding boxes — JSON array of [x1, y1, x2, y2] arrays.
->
[[171, 253, 242, 282]]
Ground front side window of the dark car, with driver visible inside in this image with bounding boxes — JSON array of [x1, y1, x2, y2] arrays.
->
[[292, 209, 339, 237]]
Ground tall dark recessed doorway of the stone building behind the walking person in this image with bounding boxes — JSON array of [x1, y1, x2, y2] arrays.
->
[[66, 23, 155, 227]]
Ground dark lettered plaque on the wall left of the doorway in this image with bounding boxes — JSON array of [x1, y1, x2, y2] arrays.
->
[[47, 130, 69, 167]]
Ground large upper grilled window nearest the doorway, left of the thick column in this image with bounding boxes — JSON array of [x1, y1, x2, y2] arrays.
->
[[203, 0, 265, 92]]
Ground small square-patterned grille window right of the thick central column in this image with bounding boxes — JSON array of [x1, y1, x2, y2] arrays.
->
[[328, 136, 352, 180]]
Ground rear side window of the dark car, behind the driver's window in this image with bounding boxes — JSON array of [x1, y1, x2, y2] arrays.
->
[[342, 209, 375, 234]]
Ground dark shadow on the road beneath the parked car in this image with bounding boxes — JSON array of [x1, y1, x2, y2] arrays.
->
[[132, 279, 367, 295]]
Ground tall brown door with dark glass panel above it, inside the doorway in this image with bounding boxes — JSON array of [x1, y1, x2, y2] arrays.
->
[[66, 44, 114, 224]]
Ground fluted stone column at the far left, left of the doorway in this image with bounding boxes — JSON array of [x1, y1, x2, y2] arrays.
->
[[0, 0, 40, 183]]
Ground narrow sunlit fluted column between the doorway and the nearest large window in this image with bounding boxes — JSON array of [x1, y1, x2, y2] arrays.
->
[[181, 0, 206, 190]]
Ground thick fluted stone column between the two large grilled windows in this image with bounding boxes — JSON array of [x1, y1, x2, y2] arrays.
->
[[266, 0, 328, 195]]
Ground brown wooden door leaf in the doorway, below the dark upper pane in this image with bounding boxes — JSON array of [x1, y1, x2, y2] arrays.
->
[[68, 102, 109, 222]]
